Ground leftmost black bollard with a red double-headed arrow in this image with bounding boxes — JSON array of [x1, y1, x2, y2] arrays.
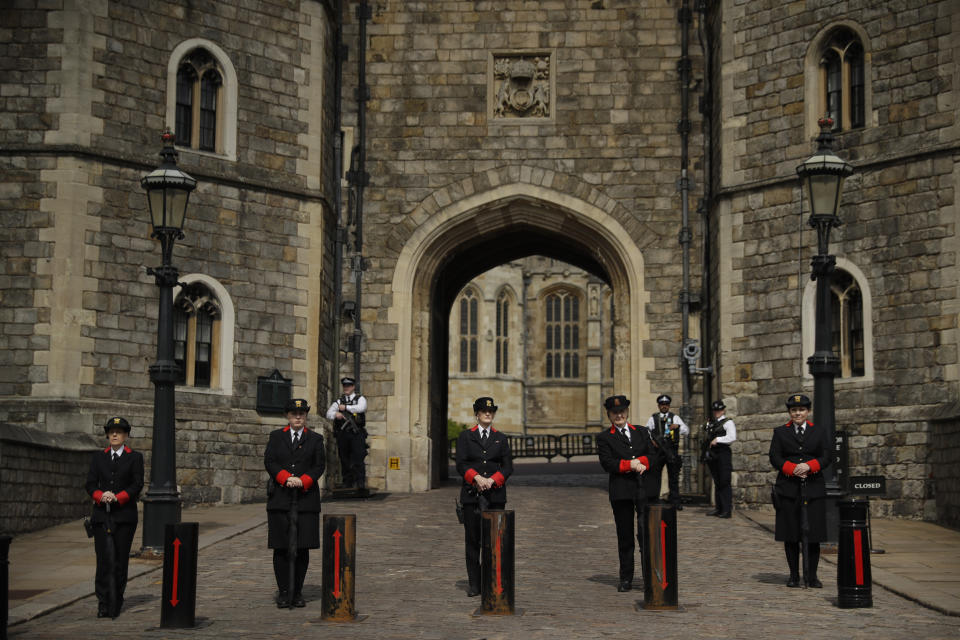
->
[[160, 522, 200, 629]]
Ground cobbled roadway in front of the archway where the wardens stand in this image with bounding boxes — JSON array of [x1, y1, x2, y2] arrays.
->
[[9, 468, 960, 640]]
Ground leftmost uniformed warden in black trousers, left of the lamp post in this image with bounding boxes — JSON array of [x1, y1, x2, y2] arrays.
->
[[85, 417, 143, 618]]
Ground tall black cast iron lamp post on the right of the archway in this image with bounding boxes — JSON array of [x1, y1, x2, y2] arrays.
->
[[797, 118, 853, 542]]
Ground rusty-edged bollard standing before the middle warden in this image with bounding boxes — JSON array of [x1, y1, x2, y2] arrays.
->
[[477, 510, 515, 616]]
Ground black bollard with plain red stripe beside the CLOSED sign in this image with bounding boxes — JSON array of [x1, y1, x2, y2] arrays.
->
[[837, 497, 873, 609]]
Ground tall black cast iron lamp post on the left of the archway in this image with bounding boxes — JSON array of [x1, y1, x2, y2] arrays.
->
[[140, 131, 197, 554]]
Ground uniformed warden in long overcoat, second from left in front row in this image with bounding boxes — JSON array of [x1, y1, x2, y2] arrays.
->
[[263, 398, 326, 609]]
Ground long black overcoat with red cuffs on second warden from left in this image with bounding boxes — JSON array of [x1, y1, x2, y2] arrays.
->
[[263, 425, 326, 549]]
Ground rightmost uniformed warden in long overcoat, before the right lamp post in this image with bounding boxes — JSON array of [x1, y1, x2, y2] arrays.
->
[[770, 394, 831, 589]]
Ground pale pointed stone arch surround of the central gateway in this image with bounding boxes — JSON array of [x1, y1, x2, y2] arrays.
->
[[384, 168, 655, 491]]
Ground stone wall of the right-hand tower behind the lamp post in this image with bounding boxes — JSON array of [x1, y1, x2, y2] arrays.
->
[[717, 1, 960, 517]]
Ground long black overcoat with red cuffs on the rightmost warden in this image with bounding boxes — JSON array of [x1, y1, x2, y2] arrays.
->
[[770, 422, 833, 542]]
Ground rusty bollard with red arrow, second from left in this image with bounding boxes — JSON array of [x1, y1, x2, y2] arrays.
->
[[320, 513, 357, 622]]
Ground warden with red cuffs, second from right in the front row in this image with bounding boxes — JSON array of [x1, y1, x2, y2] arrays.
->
[[597, 396, 652, 591]]
